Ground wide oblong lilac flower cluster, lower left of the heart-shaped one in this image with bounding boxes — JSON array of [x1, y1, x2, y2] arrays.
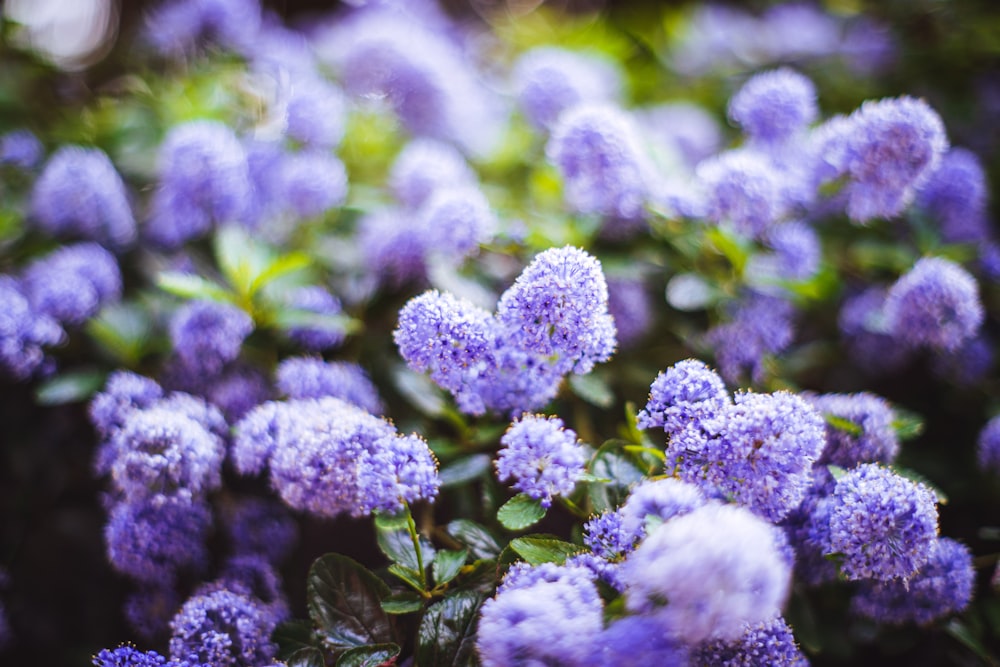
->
[[232, 397, 440, 516]]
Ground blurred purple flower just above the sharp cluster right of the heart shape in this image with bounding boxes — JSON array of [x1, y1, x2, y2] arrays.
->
[[705, 293, 795, 384]]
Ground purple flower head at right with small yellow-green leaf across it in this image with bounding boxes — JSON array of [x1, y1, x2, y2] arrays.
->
[[806, 392, 899, 468]]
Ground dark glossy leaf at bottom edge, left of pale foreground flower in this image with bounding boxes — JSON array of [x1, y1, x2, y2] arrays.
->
[[416, 591, 486, 667]]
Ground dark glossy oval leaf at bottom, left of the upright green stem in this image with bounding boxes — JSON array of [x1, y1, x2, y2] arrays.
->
[[306, 554, 395, 651]]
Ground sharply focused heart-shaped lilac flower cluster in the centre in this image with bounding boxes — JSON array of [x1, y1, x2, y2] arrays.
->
[[393, 247, 616, 414]]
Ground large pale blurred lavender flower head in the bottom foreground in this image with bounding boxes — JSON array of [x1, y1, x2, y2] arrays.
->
[[622, 504, 790, 642]]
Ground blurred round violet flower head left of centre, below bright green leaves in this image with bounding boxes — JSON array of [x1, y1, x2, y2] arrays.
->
[[170, 300, 253, 375]]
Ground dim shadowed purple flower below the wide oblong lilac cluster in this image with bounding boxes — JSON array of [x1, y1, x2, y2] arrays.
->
[[221, 496, 299, 564]]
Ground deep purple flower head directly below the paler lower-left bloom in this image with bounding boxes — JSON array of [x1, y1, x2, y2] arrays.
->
[[104, 495, 212, 583]]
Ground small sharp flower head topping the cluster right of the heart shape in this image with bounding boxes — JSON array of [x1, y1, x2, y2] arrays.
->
[[637, 359, 732, 433]]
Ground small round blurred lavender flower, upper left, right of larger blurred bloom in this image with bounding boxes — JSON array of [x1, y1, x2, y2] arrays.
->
[[275, 150, 347, 218]]
